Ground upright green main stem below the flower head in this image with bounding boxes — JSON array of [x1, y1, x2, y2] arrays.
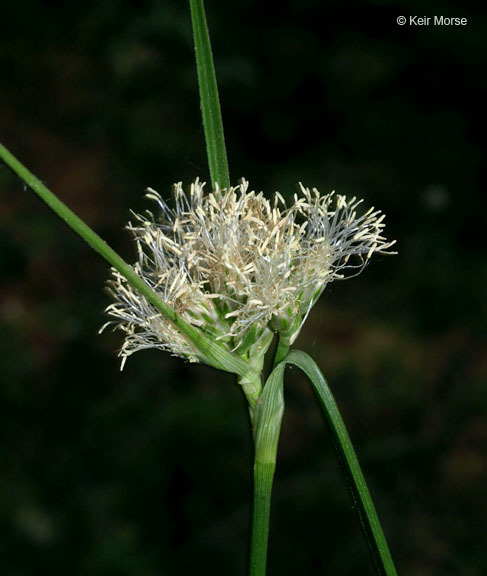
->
[[250, 364, 284, 576]]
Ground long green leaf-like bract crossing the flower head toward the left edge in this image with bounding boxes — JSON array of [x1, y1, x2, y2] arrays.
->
[[0, 144, 257, 381]]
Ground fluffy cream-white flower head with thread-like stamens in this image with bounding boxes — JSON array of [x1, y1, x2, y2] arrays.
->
[[103, 180, 394, 366]]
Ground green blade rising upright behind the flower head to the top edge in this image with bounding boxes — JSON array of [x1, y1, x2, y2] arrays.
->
[[189, 0, 230, 188]]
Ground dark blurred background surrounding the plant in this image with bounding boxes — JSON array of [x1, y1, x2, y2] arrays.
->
[[0, 0, 487, 576]]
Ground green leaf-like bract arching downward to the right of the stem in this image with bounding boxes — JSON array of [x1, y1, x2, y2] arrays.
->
[[281, 350, 397, 576]]
